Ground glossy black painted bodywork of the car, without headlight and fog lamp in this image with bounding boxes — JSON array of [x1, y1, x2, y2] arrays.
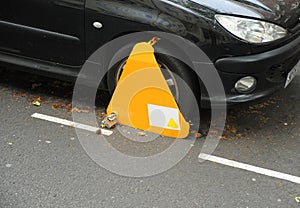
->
[[0, 0, 300, 106]]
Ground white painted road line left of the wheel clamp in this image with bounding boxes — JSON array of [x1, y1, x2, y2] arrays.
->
[[31, 113, 113, 136]]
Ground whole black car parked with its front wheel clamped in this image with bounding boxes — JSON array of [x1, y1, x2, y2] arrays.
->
[[0, 0, 300, 106]]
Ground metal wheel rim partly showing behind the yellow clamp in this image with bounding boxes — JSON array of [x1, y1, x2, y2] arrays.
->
[[114, 59, 180, 101]]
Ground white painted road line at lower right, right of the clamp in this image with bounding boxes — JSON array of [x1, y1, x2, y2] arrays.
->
[[199, 153, 300, 184]]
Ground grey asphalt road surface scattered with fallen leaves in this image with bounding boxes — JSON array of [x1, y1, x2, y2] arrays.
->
[[0, 67, 300, 208]]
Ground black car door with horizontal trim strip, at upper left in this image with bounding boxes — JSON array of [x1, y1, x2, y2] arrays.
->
[[0, 0, 85, 66]]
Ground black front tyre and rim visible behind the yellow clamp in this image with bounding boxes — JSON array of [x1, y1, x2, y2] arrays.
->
[[107, 54, 200, 120]]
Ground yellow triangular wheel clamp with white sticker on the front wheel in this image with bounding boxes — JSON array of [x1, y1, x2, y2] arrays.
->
[[107, 38, 190, 138]]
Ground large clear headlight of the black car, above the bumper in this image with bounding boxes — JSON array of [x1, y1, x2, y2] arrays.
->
[[215, 14, 287, 43]]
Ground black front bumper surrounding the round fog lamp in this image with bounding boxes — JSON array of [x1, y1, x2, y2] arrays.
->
[[201, 32, 300, 108]]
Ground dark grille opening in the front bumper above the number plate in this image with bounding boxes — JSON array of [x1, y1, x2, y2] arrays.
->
[[266, 53, 300, 82]]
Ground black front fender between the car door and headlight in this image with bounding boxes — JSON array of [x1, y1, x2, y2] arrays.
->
[[86, 0, 251, 61]]
